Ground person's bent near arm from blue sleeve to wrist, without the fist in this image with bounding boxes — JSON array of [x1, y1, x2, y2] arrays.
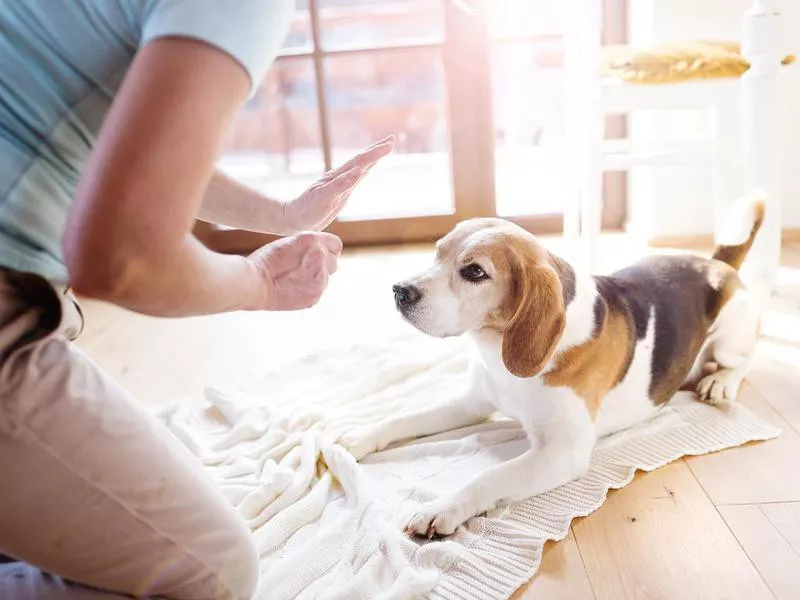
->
[[64, 38, 276, 316]]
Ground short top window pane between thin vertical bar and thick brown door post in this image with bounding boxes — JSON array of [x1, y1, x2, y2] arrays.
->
[[314, 0, 444, 49]]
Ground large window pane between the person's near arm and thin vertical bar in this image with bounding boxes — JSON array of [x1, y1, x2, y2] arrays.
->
[[219, 58, 325, 203]]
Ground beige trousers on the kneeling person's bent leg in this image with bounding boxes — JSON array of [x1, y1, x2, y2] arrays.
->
[[0, 270, 258, 600]]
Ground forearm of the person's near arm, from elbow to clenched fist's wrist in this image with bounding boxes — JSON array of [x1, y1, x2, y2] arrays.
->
[[75, 236, 268, 317]]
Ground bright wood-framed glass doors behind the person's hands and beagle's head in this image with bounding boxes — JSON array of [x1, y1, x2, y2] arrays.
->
[[203, 0, 621, 246]]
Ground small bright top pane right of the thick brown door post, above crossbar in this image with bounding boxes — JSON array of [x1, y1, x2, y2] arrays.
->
[[486, 0, 564, 39]]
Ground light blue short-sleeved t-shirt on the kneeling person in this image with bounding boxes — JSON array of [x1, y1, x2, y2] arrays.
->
[[0, 0, 295, 283]]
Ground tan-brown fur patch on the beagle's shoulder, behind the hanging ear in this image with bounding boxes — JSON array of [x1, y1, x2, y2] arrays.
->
[[542, 296, 636, 418]]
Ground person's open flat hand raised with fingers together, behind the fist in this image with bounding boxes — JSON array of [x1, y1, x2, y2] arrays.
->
[[284, 136, 394, 231]]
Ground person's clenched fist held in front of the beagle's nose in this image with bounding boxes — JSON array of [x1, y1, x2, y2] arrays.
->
[[248, 232, 342, 310]]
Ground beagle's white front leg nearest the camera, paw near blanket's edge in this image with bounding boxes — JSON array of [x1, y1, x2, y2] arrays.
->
[[405, 428, 594, 537]]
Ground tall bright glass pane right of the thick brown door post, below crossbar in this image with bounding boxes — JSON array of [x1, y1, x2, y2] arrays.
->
[[491, 43, 573, 216]]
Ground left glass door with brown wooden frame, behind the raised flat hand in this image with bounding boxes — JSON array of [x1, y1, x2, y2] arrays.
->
[[209, 0, 466, 249]]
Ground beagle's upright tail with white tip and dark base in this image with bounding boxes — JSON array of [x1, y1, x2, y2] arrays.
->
[[713, 194, 766, 270]]
